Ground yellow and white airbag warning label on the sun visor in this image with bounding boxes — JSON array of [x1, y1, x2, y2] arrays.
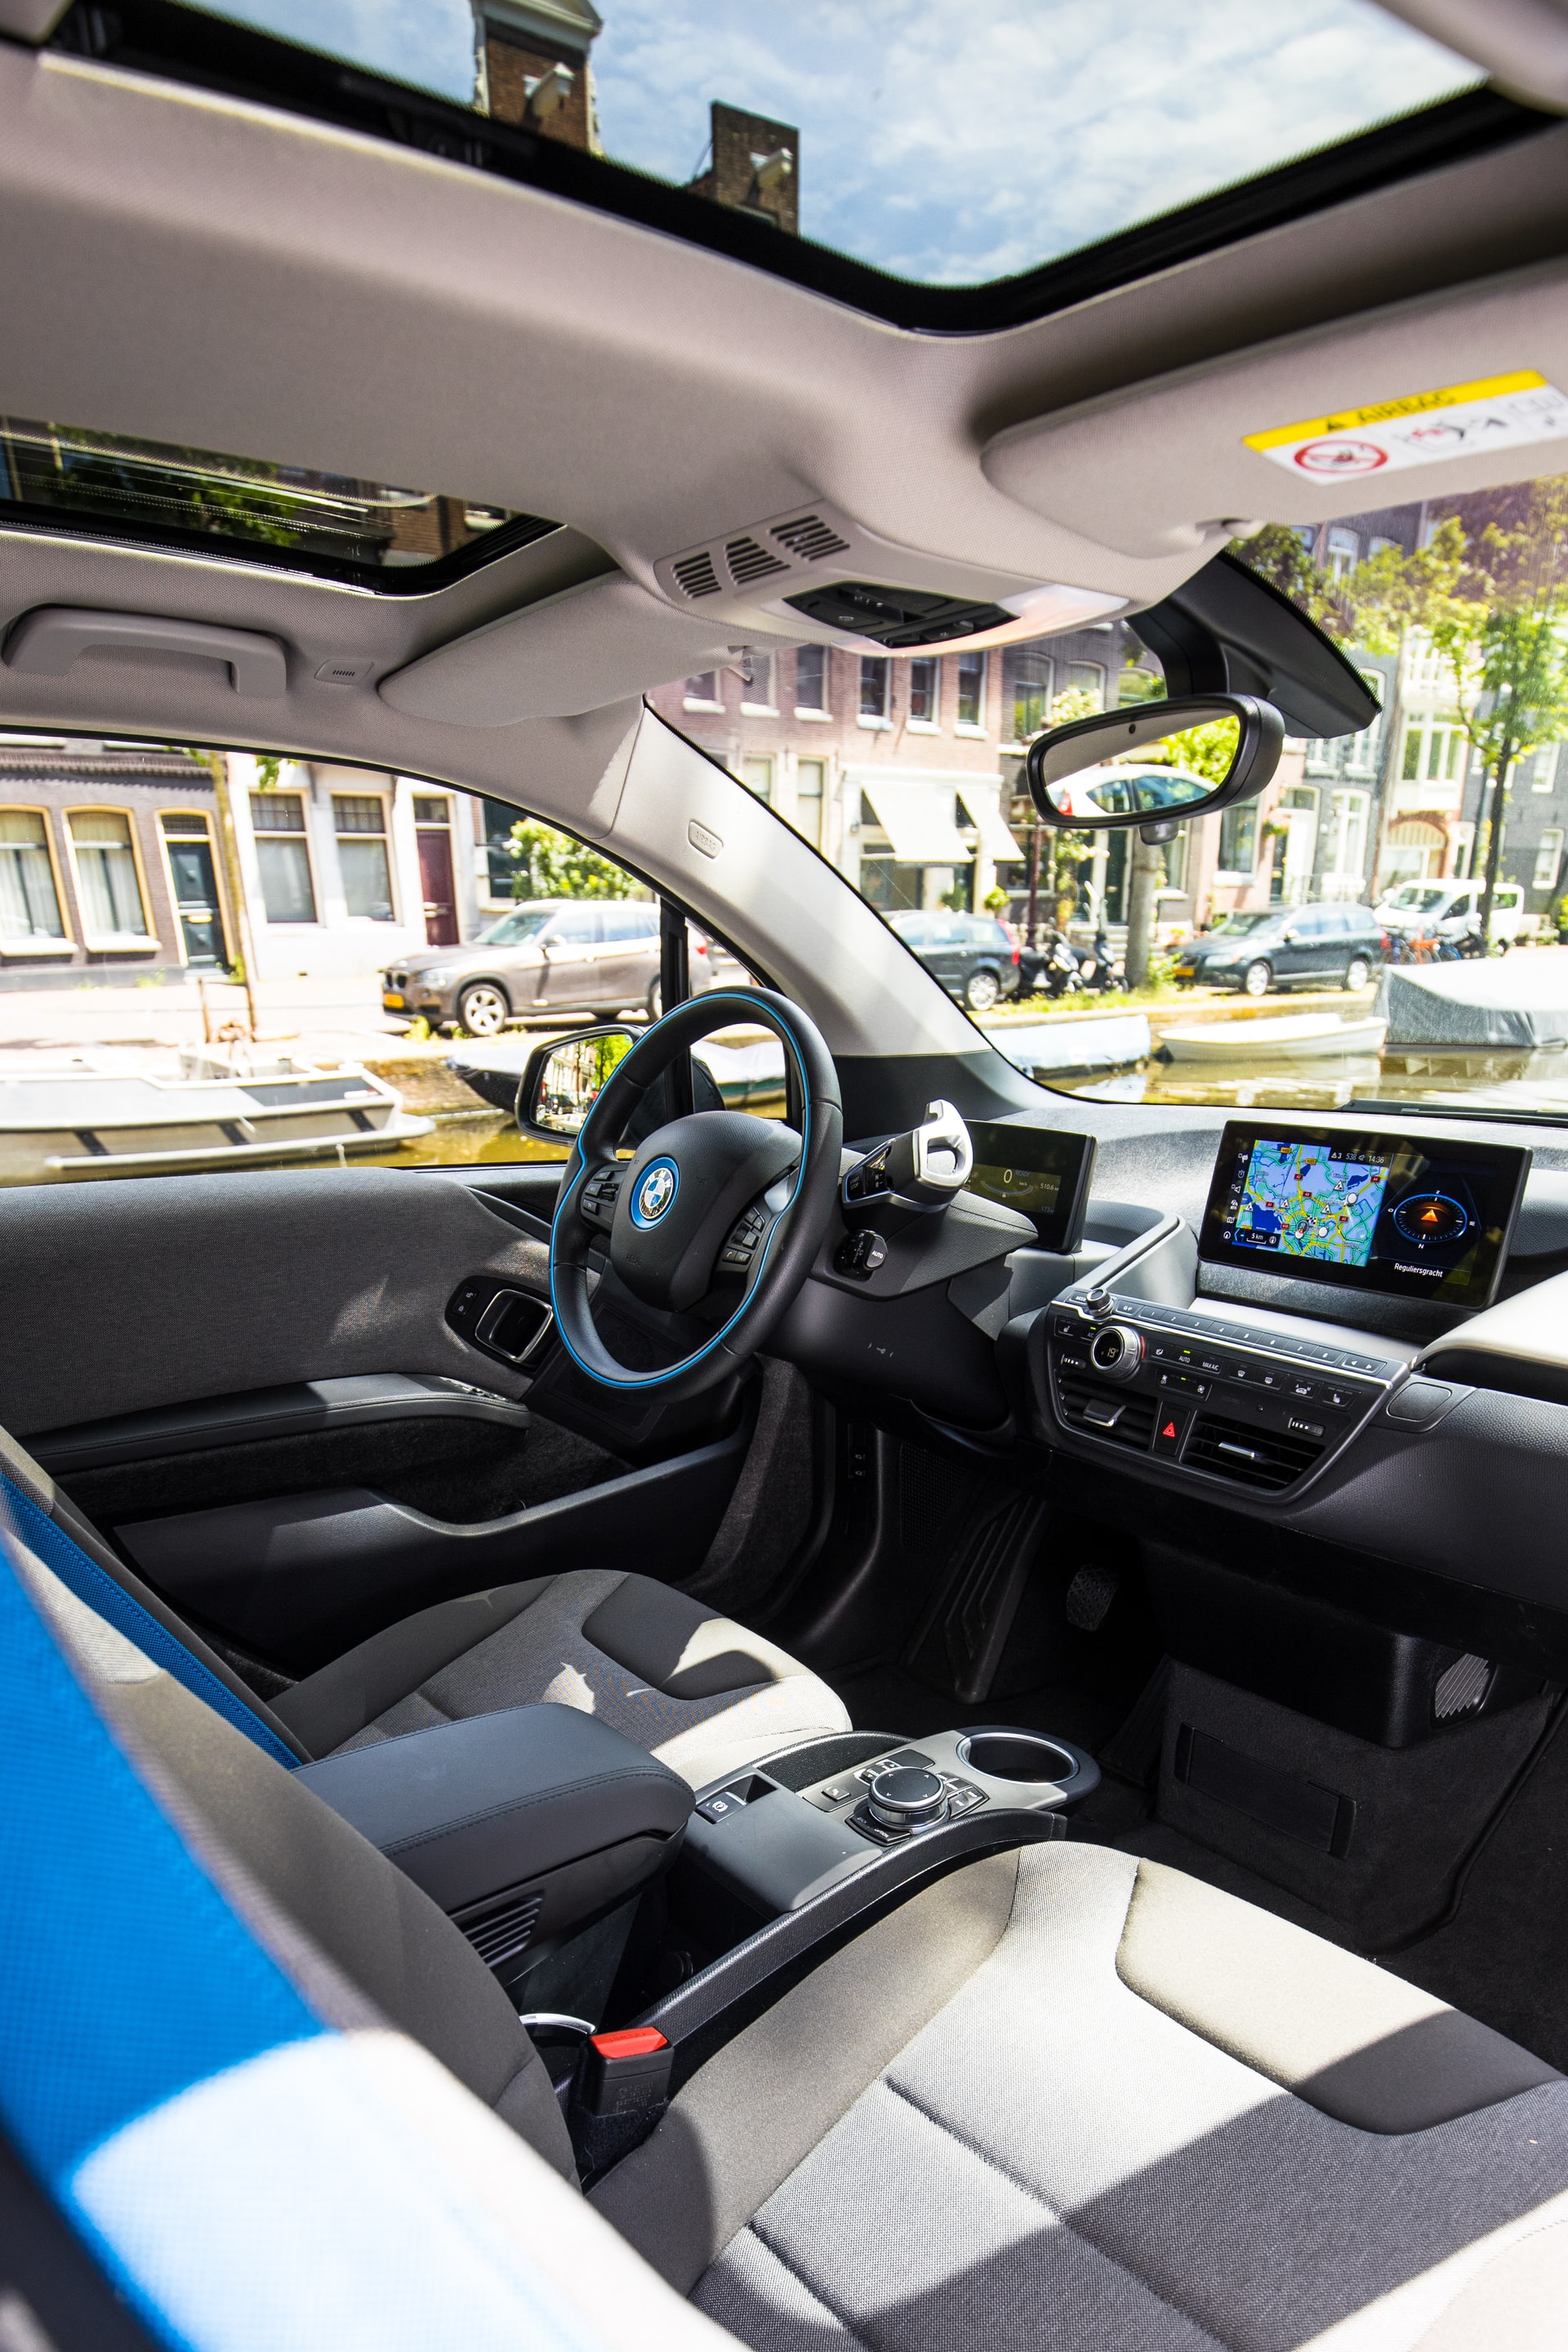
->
[[1246, 367, 1568, 480]]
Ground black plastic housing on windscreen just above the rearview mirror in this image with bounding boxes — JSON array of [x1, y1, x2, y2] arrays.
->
[[1133, 555, 1383, 738]]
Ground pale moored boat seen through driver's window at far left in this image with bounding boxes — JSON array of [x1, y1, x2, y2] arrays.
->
[[0, 1049, 435, 1183]]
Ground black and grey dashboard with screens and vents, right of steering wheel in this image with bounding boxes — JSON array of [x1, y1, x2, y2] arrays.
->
[[778, 1101, 1568, 1614]]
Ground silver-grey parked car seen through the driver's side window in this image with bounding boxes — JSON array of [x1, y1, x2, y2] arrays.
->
[[381, 898, 733, 1037]]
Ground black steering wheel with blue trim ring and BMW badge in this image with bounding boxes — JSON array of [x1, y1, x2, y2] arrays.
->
[[550, 988, 844, 1401]]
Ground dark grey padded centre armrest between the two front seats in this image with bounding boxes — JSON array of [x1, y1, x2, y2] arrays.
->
[[296, 1705, 691, 1985]]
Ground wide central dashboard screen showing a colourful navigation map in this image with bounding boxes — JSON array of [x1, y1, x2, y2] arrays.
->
[[1199, 1120, 1530, 1307]]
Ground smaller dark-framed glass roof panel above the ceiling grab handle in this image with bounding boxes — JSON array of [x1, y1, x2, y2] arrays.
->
[[0, 416, 555, 590]]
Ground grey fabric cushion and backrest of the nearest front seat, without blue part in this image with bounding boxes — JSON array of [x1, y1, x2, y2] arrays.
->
[[24, 1559, 1568, 2352]]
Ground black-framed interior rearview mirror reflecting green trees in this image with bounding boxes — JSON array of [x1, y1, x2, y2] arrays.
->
[[1025, 694, 1286, 840]]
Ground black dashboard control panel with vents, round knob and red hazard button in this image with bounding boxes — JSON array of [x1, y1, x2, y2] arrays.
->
[[1044, 1291, 1405, 1494]]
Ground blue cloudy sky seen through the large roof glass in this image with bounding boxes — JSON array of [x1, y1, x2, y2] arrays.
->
[[190, 0, 1477, 284]]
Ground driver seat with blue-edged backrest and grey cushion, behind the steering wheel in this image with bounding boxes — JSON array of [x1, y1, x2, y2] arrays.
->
[[0, 1430, 851, 1788]]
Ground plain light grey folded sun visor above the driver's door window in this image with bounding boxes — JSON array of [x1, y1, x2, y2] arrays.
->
[[378, 572, 742, 727]]
